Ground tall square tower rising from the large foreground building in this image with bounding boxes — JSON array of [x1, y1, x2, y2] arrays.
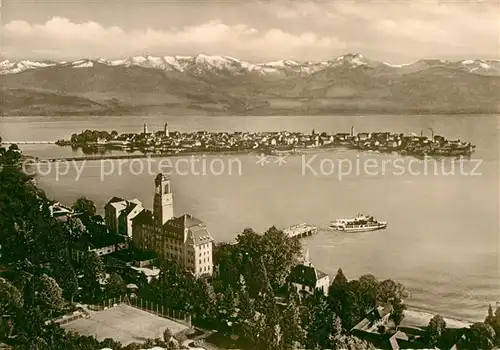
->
[[153, 173, 174, 226]]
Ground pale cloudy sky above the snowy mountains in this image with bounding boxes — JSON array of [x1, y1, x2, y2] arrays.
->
[[0, 0, 500, 63]]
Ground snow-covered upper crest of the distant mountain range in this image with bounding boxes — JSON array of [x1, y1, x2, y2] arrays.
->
[[0, 53, 500, 76]]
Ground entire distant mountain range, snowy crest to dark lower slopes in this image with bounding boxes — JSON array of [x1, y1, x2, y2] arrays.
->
[[0, 54, 500, 115]]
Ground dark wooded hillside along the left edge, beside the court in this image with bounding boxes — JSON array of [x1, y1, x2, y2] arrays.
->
[[0, 146, 131, 349]]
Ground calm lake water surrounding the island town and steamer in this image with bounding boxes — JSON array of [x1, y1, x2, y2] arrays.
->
[[0, 116, 500, 320]]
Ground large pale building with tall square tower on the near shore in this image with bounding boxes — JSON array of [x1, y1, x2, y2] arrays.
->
[[132, 174, 214, 277]]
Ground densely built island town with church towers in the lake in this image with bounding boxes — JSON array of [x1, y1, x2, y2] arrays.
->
[[56, 123, 475, 157]]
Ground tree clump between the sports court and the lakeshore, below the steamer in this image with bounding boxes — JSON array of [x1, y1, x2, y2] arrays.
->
[[132, 227, 408, 349]]
